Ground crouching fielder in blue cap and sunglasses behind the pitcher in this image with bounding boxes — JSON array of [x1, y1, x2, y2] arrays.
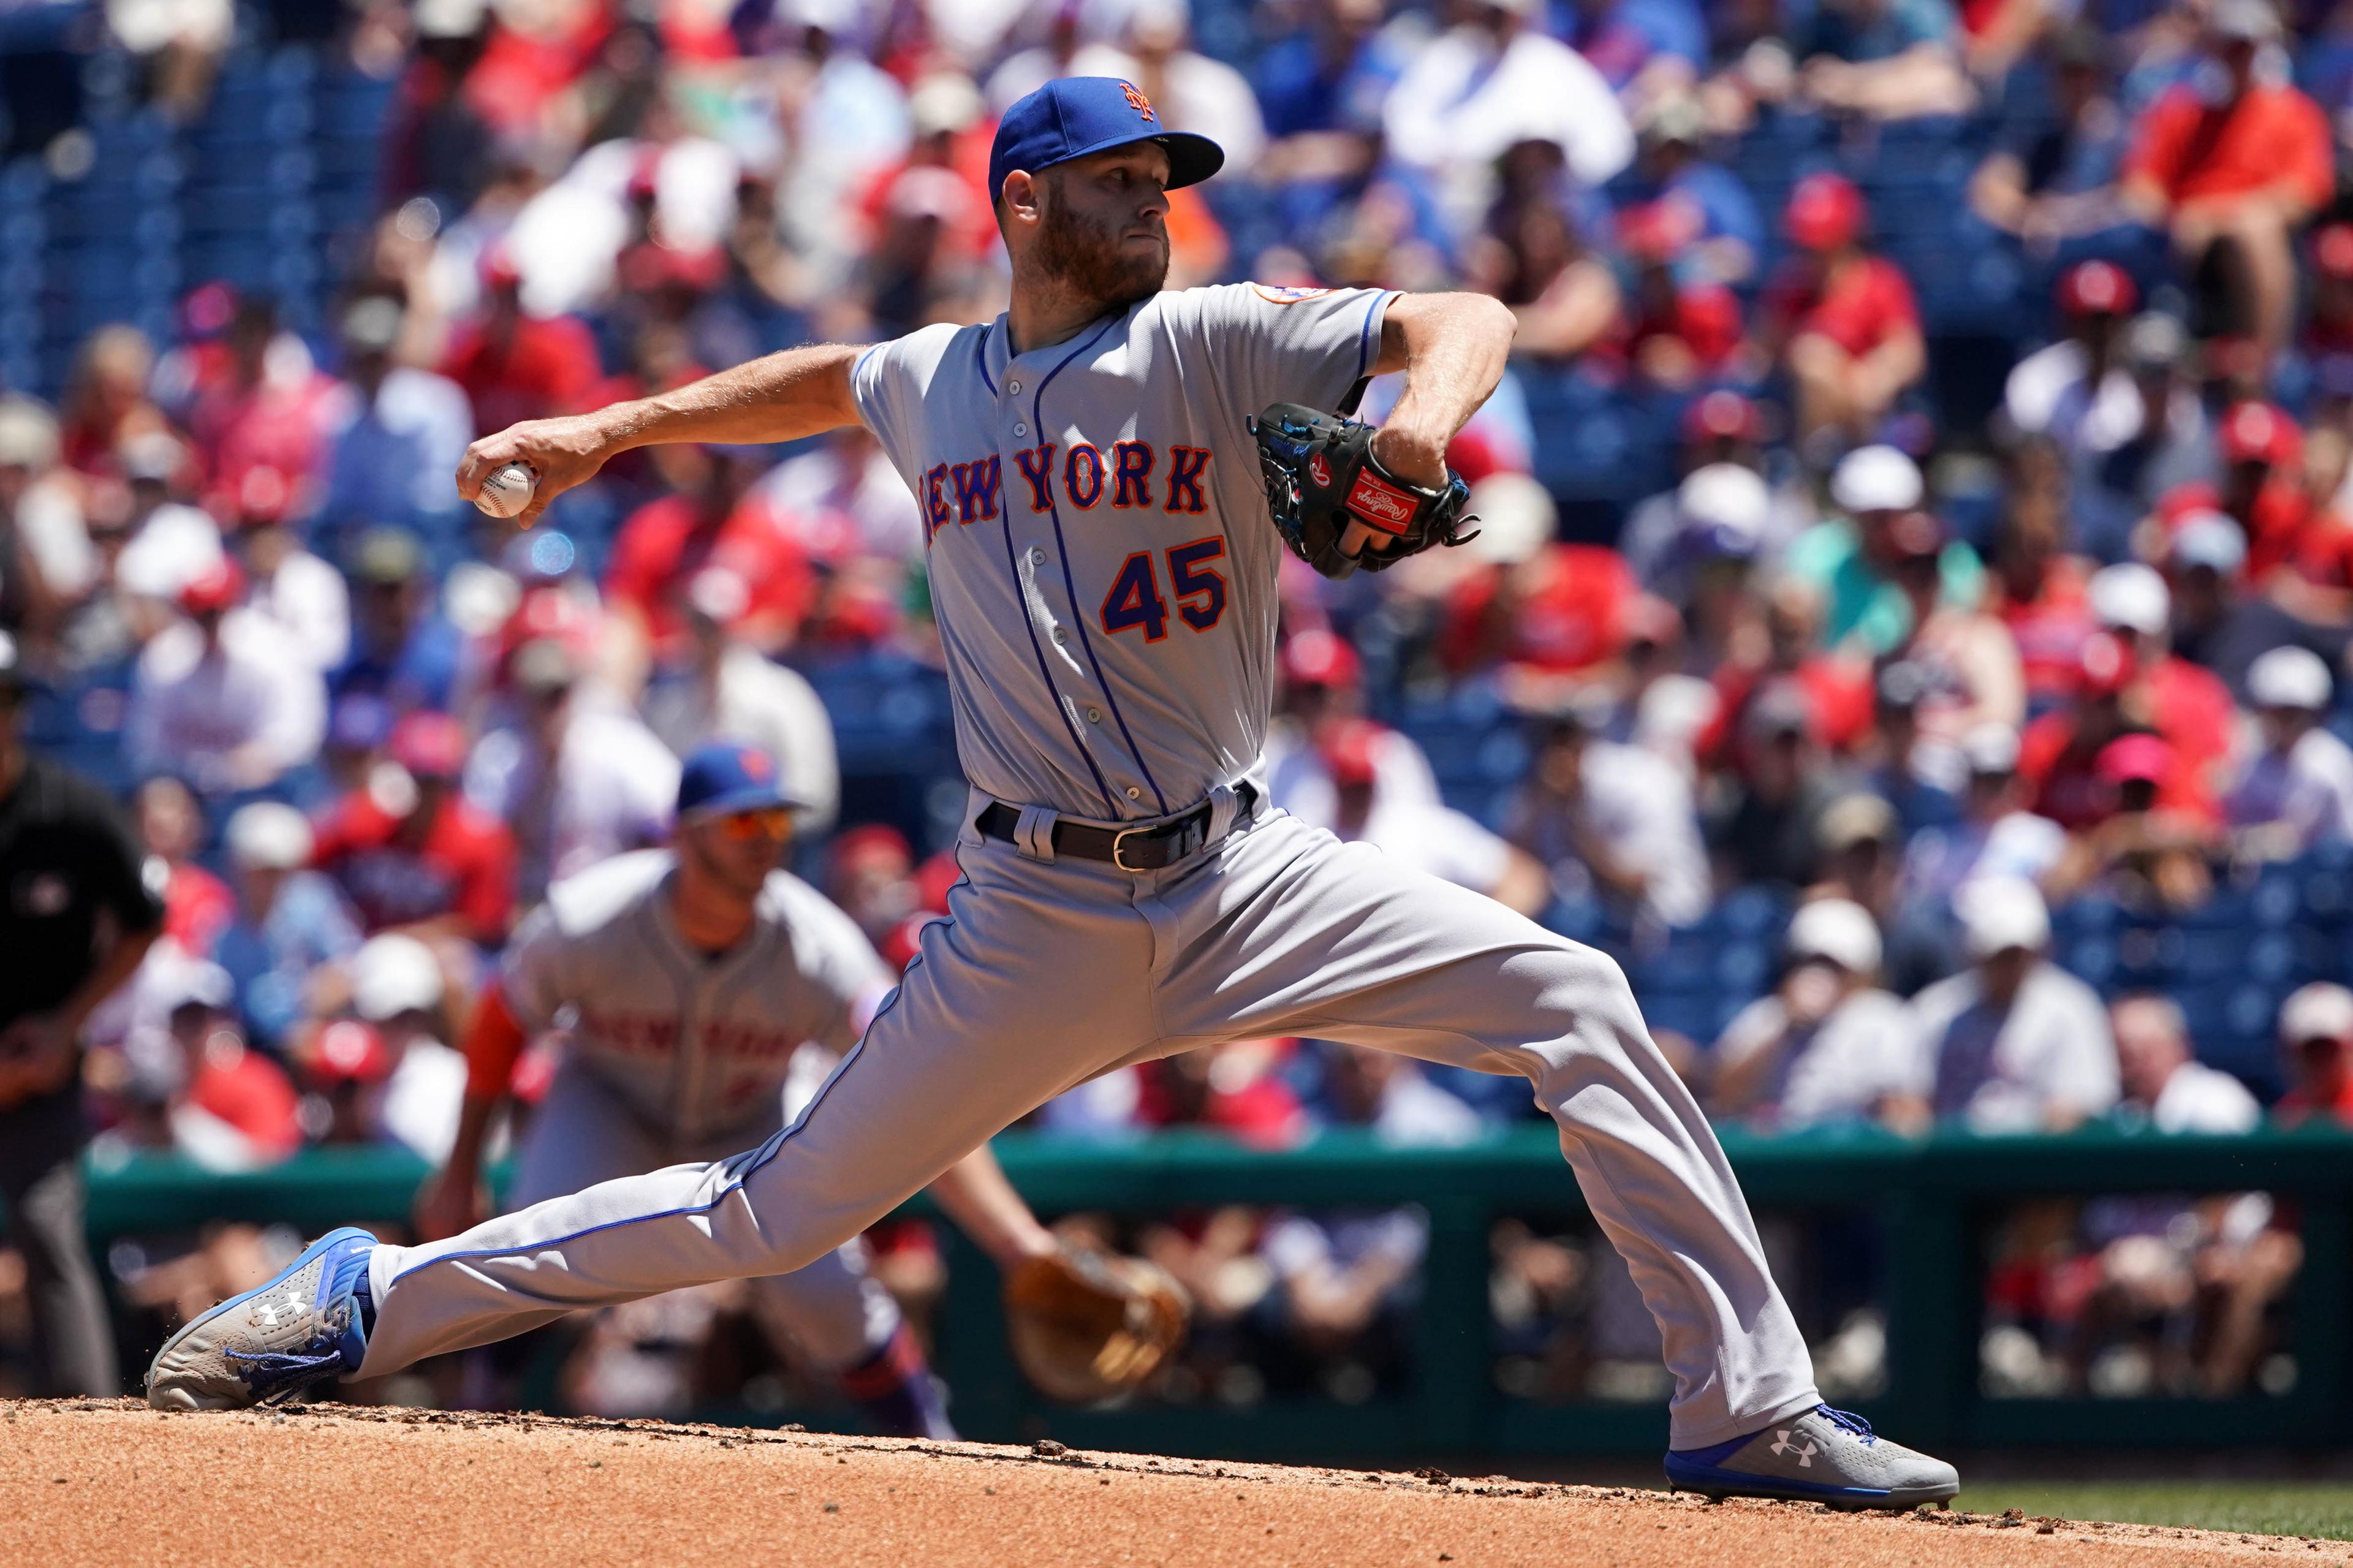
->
[[417, 741, 1181, 1439]]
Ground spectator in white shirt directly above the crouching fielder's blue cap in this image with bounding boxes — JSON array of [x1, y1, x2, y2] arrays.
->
[[640, 567, 843, 836]]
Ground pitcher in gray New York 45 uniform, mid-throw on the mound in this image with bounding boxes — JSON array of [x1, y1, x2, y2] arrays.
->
[[151, 78, 1958, 1507]]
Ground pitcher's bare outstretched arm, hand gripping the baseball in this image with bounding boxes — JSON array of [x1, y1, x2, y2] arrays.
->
[[457, 344, 863, 528]]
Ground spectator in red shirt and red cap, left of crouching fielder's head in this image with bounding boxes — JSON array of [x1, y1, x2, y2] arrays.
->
[[313, 713, 515, 944]]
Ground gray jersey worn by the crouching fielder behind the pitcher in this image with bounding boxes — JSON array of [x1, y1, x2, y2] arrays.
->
[[499, 850, 892, 1144]]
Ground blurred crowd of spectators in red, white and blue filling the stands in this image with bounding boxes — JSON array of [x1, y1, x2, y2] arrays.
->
[[0, 0, 2353, 1387]]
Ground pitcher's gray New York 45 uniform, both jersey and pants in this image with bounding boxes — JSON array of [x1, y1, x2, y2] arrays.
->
[[362, 285, 1819, 1448]]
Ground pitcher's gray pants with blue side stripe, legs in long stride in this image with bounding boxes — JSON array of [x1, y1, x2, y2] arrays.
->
[[360, 798, 1819, 1448]]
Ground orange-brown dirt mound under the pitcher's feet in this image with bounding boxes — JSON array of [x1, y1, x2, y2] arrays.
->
[[0, 1401, 2344, 1568]]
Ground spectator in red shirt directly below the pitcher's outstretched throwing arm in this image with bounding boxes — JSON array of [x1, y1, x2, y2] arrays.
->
[[605, 445, 816, 657]]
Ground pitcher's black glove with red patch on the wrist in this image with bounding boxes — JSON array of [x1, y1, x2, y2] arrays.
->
[[1249, 403, 1476, 577]]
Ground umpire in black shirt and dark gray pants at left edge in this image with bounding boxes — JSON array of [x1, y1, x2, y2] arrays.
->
[[0, 631, 162, 1396]]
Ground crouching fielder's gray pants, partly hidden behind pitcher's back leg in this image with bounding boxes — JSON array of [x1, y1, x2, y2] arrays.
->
[[508, 1062, 899, 1373]]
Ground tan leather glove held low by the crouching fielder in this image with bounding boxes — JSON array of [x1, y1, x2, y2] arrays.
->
[[1005, 1248, 1193, 1406]]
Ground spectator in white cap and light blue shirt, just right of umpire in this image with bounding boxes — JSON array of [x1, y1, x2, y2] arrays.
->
[[214, 800, 360, 1050]]
